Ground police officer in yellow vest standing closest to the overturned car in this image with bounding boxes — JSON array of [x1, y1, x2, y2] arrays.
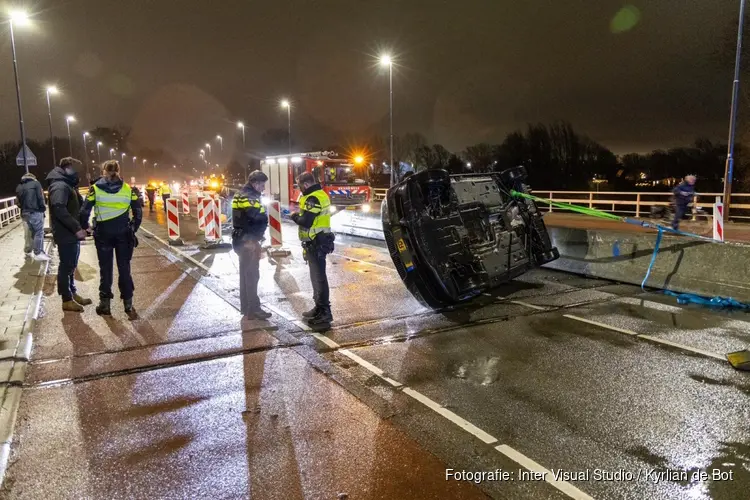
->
[[292, 172, 334, 327]]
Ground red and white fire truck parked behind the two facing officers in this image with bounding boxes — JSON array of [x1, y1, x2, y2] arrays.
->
[[260, 151, 372, 213]]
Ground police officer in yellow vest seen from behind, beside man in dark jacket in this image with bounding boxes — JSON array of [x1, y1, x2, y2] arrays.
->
[[81, 160, 143, 319]]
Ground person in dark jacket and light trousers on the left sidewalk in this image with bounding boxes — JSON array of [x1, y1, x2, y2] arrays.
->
[[16, 173, 49, 261]]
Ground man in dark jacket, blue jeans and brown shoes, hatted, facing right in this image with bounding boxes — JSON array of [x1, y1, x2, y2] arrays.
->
[[47, 157, 92, 312]]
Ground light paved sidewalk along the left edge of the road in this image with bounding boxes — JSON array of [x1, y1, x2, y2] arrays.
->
[[0, 221, 49, 482]]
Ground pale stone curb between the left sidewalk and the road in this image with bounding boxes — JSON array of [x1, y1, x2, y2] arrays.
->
[[0, 235, 52, 487]]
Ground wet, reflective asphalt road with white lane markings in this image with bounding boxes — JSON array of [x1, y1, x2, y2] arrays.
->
[[2, 199, 750, 499]]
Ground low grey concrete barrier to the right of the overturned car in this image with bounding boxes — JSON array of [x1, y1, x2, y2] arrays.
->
[[545, 227, 750, 302]]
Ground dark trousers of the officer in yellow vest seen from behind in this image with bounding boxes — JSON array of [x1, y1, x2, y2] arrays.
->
[[94, 230, 135, 300]]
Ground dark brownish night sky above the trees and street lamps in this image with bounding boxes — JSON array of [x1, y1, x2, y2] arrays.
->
[[0, 0, 750, 158]]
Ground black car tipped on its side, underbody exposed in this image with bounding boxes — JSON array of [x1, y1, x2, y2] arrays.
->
[[381, 167, 560, 309]]
